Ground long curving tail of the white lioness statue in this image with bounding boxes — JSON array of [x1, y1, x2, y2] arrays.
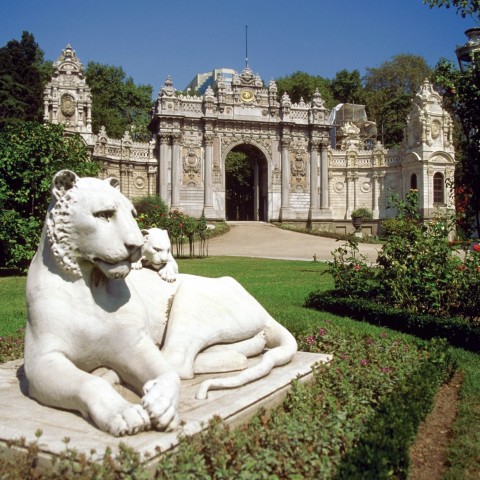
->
[[196, 319, 297, 400]]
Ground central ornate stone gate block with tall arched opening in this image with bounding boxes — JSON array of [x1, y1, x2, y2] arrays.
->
[[150, 67, 332, 221]]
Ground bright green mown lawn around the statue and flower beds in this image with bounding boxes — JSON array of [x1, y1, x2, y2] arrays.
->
[[0, 257, 480, 479]]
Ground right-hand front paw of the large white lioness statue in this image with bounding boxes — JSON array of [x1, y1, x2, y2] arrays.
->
[[142, 372, 180, 431]]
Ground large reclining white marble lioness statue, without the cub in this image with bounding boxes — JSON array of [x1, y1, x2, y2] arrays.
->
[[25, 170, 297, 436]]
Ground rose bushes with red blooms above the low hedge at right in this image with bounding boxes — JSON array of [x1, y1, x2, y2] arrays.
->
[[328, 190, 480, 319]]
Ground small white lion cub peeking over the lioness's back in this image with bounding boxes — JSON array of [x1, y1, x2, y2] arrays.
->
[[132, 228, 178, 282]]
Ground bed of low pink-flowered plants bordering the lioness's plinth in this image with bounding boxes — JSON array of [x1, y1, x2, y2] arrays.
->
[[0, 320, 454, 480]]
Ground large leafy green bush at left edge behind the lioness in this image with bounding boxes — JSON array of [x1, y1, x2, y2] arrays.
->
[[0, 121, 99, 269]]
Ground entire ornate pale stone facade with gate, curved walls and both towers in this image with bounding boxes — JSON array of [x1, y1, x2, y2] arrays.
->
[[45, 46, 455, 234]]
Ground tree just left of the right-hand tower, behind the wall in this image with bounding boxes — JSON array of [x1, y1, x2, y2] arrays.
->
[[364, 54, 431, 147]]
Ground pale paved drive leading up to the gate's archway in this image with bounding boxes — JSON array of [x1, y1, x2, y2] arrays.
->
[[204, 222, 381, 263]]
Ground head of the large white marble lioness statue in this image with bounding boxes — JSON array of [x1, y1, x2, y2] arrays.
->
[[46, 170, 143, 278]]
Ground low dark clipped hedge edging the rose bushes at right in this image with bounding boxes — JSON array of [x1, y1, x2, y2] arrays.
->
[[305, 291, 480, 352]]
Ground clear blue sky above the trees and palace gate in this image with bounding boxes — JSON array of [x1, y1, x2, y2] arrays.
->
[[0, 0, 476, 94]]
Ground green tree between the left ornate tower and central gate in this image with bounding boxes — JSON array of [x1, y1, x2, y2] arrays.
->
[[85, 62, 153, 141]]
